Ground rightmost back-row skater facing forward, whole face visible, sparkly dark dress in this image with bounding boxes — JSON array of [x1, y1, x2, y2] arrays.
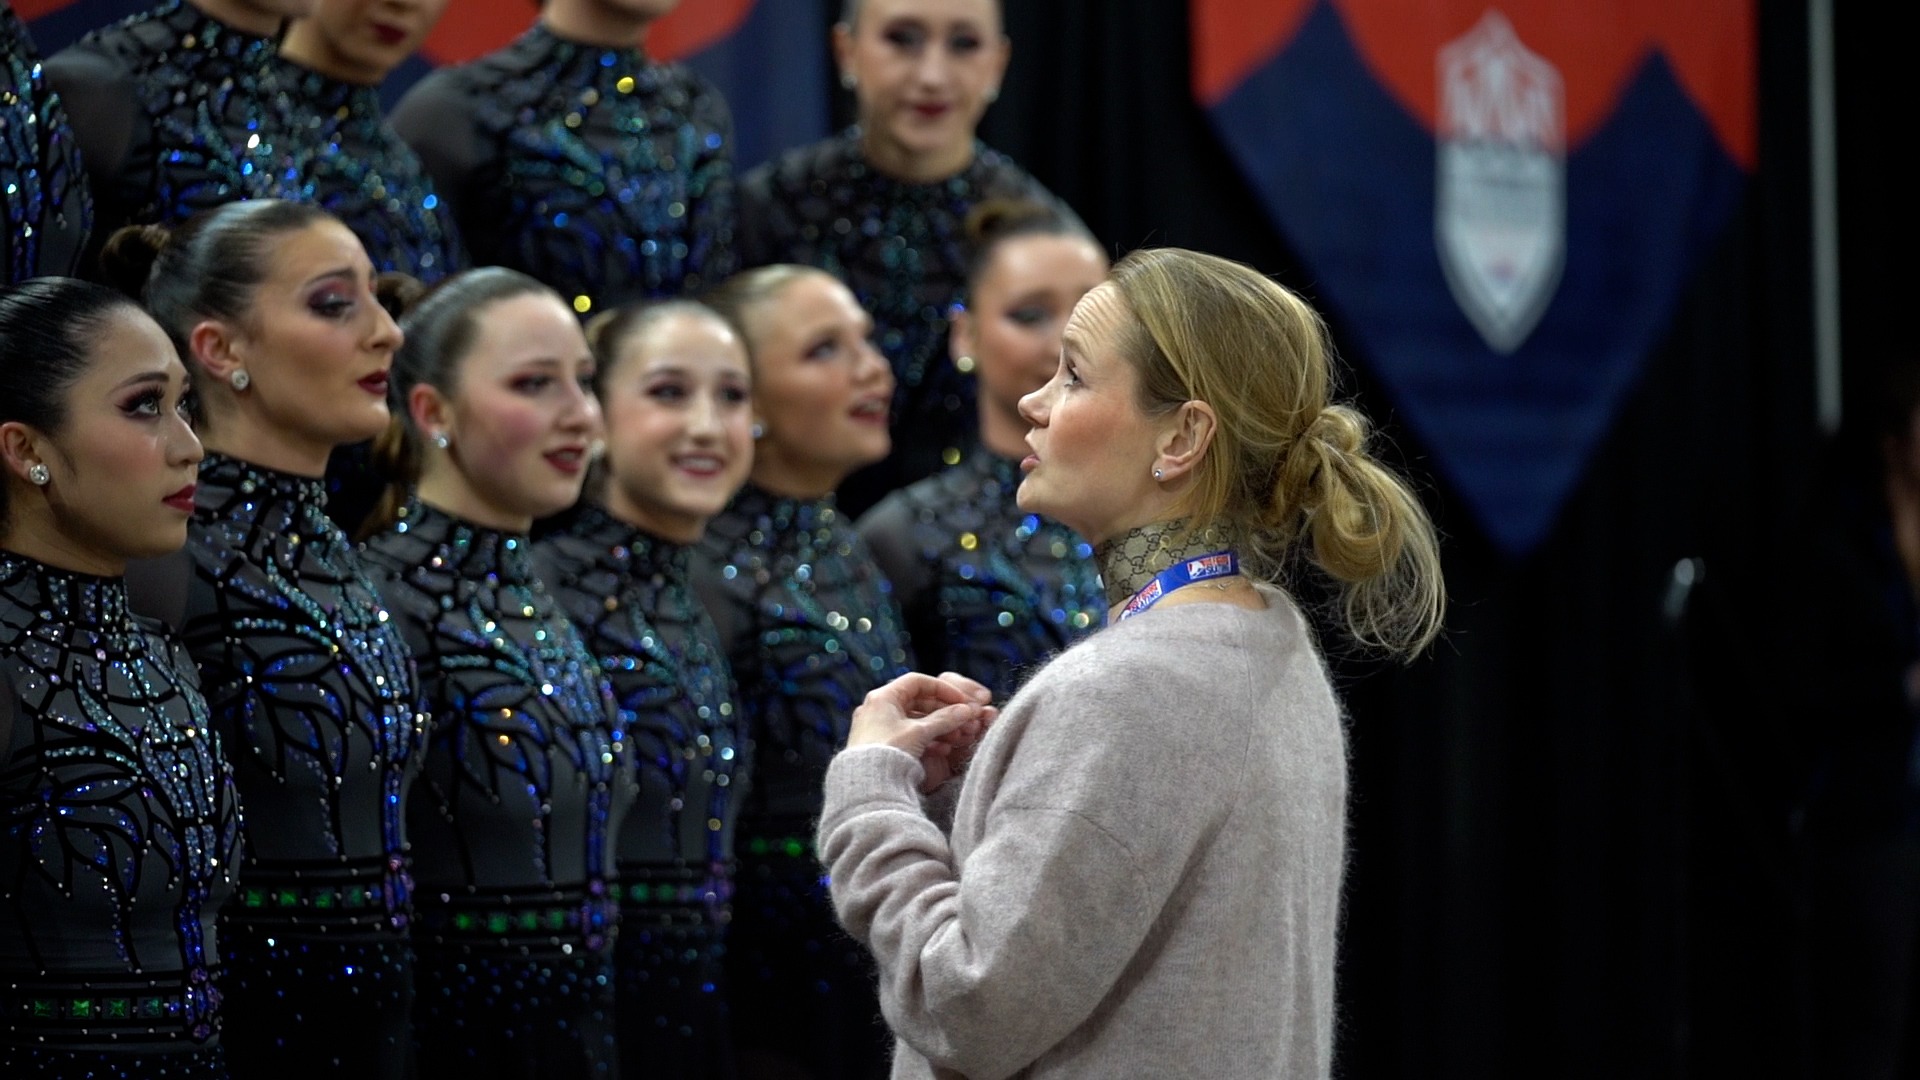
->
[[739, 0, 1071, 513]]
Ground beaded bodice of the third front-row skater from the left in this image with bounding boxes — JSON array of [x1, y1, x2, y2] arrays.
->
[[367, 500, 634, 909]]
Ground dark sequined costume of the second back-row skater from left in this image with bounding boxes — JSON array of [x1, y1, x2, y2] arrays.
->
[[46, 0, 276, 265]]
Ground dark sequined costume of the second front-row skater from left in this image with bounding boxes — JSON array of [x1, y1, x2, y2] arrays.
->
[[134, 454, 426, 1076]]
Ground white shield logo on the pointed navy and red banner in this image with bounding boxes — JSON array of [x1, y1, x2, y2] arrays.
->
[[1434, 12, 1567, 354]]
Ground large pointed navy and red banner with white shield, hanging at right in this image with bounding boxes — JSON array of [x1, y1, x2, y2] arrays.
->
[[1192, 0, 1757, 553]]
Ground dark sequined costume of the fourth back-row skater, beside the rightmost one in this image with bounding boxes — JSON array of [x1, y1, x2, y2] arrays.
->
[[394, 25, 733, 313]]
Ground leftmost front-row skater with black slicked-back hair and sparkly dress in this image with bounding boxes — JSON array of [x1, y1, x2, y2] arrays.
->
[[0, 279, 240, 1080]]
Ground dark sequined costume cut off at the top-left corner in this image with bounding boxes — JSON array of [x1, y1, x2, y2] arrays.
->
[[0, 0, 94, 284]]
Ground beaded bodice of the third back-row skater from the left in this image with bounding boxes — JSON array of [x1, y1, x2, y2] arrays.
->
[[273, 58, 465, 284]]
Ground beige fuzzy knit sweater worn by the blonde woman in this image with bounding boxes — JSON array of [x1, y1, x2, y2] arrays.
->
[[820, 590, 1346, 1080]]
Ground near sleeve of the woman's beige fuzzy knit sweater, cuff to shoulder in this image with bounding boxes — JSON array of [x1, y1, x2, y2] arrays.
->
[[820, 638, 1248, 1080]]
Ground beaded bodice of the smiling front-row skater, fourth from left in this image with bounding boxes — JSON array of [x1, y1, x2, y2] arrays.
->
[[536, 505, 747, 874]]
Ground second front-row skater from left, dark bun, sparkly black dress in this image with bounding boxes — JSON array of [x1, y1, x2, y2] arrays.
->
[[102, 200, 424, 1078]]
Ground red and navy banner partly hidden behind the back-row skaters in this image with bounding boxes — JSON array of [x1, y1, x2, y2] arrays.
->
[[13, 0, 833, 169]]
